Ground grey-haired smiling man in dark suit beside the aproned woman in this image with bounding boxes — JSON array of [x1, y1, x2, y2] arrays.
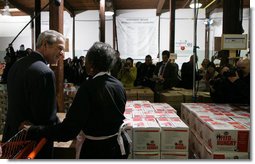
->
[[2, 30, 65, 158]]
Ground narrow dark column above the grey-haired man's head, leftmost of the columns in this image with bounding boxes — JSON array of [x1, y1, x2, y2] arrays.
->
[[35, 0, 41, 40]]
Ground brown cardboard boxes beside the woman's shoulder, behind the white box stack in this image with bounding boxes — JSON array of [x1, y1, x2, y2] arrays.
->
[[126, 87, 154, 102]]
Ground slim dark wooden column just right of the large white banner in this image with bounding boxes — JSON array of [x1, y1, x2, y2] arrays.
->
[[169, 0, 176, 53]]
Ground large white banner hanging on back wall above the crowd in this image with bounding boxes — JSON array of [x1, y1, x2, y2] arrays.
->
[[116, 17, 158, 59]]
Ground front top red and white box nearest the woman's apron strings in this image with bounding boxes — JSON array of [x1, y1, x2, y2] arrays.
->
[[133, 118, 160, 152]]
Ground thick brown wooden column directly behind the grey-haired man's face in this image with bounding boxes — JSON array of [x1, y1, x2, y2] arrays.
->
[[50, 0, 65, 112]]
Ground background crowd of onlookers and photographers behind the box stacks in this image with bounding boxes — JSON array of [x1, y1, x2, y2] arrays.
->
[[64, 50, 250, 104]]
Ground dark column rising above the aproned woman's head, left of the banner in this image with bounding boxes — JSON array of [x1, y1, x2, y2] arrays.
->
[[99, 0, 105, 42]]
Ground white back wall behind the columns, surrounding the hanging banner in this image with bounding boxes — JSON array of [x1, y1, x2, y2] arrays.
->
[[0, 9, 250, 67]]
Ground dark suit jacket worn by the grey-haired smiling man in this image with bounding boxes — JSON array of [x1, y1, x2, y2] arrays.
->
[[3, 52, 58, 158]]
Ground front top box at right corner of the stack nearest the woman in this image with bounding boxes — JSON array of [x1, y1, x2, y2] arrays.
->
[[157, 117, 189, 152]]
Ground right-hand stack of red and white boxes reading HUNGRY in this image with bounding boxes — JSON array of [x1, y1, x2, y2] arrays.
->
[[181, 103, 250, 159]]
